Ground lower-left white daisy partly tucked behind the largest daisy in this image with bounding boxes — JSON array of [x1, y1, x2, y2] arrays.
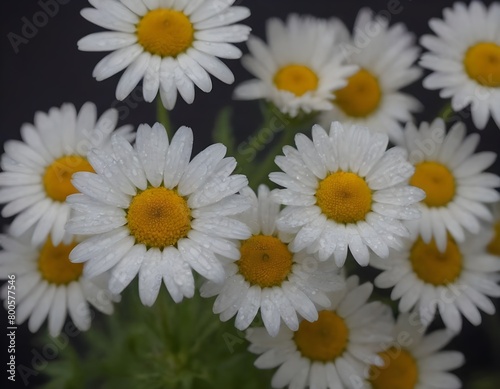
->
[[0, 235, 118, 336]]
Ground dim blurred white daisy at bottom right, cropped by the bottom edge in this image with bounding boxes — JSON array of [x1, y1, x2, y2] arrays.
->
[[369, 314, 465, 389]]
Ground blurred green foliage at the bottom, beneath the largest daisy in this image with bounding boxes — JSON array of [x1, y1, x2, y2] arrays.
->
[[42, 286, 272, 389]]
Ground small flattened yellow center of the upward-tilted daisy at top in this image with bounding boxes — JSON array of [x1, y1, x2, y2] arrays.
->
[[274, 65, 318, 96]]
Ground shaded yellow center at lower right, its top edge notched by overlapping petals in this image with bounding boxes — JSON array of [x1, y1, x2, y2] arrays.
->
[[410, 236, 462, 286]]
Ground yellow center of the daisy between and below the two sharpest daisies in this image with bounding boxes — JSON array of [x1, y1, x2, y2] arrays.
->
[[237, 235, 292, 288]]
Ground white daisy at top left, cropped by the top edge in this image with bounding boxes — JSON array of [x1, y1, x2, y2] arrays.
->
[[78, 0, 250, 109]]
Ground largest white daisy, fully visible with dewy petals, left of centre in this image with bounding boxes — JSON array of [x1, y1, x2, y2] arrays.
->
[[66, 123, 250, 306]]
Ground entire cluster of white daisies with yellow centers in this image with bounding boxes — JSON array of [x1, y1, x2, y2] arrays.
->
[[0, 0, 500, 389]]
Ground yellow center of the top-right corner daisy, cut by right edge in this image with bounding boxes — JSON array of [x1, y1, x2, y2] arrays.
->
[[464, 42, 500, 88]]
